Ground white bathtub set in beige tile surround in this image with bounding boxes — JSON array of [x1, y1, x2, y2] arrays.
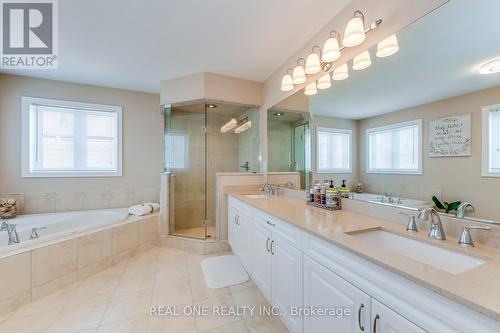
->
[[0, 208, 129, 255]]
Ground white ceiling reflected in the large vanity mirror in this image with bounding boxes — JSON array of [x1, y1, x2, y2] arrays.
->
[[310, 0, 500, 119]]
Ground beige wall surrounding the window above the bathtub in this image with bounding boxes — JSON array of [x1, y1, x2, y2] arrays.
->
[[0, 74, 163, 193]]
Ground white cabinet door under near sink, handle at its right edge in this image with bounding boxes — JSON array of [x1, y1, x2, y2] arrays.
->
[[304, 256, 370, 333]]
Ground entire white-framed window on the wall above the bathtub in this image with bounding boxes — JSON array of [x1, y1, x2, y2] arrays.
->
[[22, 97, 122, 177]]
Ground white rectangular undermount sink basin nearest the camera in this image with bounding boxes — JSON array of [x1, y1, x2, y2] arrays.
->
[[350, 229, 486, 274]]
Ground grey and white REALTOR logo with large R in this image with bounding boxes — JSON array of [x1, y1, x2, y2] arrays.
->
[[0, 0, 58, 69]]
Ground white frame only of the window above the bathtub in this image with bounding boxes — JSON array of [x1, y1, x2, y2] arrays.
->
[[21, 96, 123, 178]]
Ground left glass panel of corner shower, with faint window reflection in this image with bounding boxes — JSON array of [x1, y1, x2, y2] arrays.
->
[[164, 102, 209, 239]]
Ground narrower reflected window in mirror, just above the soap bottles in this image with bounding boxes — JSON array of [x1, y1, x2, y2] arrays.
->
[[316, 127, 352, 173]]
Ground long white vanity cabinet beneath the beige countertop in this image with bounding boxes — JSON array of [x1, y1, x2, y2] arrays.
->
[[228, 197, 500, 333]]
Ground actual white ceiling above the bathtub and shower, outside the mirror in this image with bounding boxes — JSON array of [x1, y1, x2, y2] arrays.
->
[[2, 0, 349, 92]]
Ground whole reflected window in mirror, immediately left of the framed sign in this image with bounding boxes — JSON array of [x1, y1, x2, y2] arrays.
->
[[366, 119, 422, 174]]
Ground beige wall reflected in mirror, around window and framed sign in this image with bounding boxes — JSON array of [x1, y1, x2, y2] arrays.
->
[[359, 86, 500, 220]]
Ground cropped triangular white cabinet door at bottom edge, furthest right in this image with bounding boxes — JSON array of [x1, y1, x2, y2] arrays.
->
[[371, 298, 425, 333]]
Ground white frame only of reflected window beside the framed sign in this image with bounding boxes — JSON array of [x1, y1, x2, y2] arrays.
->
[[365, 119, 424, 175]]
